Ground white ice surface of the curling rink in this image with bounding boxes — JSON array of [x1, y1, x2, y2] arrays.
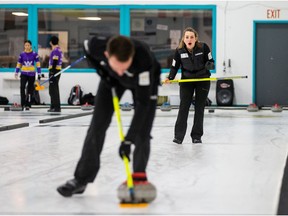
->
[[0, 108, 288, 215]]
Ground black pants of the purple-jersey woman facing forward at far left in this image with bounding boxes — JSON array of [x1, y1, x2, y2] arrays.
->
[[20, 74, 35, 107]]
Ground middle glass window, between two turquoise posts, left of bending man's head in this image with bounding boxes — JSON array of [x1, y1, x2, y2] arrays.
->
[[38, 9, 120, 68]]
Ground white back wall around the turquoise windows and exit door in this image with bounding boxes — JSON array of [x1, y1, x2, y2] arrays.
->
[[0, 0, 288, 105]]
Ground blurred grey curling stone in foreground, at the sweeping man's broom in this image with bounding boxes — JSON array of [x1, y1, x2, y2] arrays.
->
[[117, 182, 157, 203]]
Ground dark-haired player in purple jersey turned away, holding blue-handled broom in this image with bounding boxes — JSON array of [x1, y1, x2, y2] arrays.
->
[[48, 36, 63, 112]]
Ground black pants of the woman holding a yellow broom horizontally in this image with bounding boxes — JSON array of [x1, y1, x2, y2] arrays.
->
[[174, 81, 210, 141]]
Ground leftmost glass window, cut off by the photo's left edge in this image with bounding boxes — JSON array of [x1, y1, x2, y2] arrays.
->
[[0, 8, 28, 68]]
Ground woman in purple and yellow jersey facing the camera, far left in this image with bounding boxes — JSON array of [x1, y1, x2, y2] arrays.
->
[[15, 40, 41, 110]]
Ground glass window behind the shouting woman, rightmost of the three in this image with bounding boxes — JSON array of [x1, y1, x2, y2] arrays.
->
[[130, 9, 212, 68]]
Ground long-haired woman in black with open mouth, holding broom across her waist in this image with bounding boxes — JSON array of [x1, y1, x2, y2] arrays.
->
[[165, 27, 214, 144]]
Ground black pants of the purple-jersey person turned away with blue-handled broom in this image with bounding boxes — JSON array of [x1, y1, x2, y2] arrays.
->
[[49, 72, 61, 109]]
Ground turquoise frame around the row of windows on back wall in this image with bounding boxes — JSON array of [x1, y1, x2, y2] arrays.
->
[[0, 4, 216, 73]]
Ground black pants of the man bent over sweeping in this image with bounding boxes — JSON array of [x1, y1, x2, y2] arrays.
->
[[74, 81, 157, 183]]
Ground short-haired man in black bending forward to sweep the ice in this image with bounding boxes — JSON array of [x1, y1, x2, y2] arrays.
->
[[57, 36, 161, 197]]
